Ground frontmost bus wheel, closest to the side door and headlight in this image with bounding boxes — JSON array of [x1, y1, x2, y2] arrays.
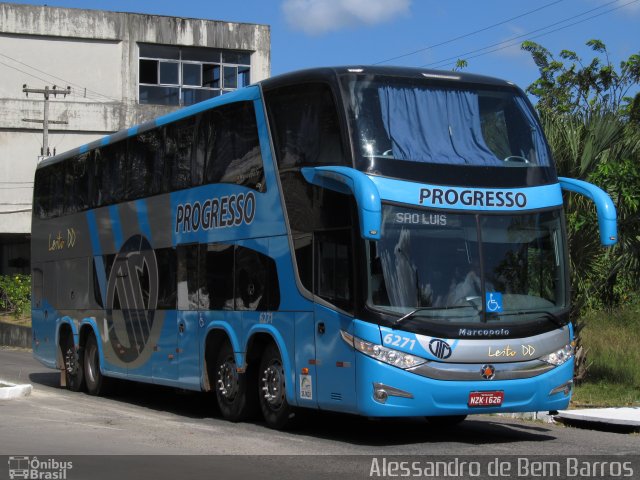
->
[[258, 344, 295, 430]]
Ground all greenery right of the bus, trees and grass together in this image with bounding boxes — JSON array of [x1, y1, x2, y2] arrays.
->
[[522, 40, 640, 390]]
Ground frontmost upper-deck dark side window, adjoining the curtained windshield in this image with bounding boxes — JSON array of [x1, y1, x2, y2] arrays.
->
[[265, 84, 350, 171]]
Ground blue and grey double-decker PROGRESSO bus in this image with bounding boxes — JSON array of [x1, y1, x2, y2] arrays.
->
[[32, 67, 616, 428]]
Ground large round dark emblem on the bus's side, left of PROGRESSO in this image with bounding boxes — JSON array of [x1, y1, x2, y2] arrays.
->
[[106, 235, 158, 363]]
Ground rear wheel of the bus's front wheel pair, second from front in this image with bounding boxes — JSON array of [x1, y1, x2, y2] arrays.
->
[[214, 341, 255, 422]]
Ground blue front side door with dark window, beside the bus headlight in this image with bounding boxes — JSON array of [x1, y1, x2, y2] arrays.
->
[[314, 229, 357, 412]]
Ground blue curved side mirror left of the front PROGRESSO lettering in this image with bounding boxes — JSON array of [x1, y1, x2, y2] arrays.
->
[[301, 166, 382, 240]]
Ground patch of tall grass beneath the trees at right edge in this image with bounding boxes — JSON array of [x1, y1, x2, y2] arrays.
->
[[572, 303, 640, 407]]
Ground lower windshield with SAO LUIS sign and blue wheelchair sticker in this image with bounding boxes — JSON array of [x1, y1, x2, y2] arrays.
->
[[368, 205, 567, 323]]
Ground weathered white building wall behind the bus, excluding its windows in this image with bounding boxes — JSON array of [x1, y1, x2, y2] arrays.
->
[[0, 2, 270, 240]]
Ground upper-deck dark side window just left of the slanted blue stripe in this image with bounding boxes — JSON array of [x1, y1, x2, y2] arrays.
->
[[202, 102, 264, 191]]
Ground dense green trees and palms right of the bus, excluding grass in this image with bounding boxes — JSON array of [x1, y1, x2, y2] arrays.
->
[[522, 40, 640, 380]]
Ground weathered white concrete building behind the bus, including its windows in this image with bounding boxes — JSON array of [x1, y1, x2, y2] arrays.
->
[[0, 3, 270, 274]]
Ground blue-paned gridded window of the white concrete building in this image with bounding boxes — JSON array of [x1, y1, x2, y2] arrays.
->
[[138, 44, 251, 106]]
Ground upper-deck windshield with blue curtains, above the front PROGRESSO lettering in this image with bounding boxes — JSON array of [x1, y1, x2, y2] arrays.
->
[[343, 75, 551, 167]]
